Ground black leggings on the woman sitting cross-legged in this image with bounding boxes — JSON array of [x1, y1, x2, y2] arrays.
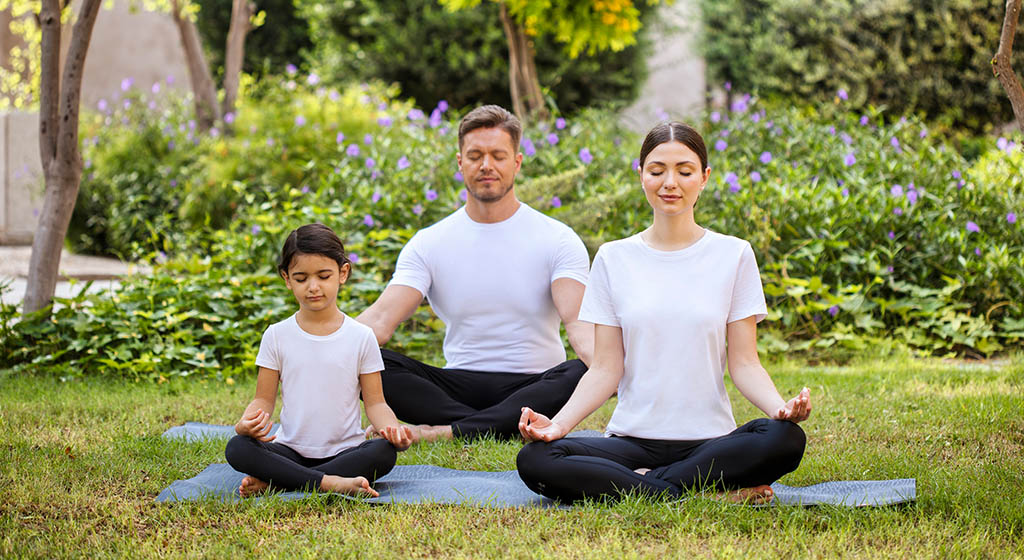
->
[[516, 418, 807, 502]]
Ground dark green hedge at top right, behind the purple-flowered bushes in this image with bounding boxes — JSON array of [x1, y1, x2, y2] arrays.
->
[[700, 0, 1024, 131]]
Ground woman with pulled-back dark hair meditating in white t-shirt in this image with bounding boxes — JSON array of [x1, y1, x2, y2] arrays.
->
[[517, 123, 811, 502]]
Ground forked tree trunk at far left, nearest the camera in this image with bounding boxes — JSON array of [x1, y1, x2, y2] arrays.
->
[[24, 0, 103, 313]]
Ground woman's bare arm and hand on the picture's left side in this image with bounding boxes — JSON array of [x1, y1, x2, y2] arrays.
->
[[519, 325, 626, 441]]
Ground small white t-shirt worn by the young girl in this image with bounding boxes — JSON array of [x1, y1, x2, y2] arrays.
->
[[256, 315, 384, 459]]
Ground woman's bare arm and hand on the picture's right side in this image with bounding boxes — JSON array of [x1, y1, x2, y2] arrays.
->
[[725, 315, 811, 422]]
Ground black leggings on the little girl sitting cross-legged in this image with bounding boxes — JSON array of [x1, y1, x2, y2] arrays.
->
[[224, 435, 398, 490]]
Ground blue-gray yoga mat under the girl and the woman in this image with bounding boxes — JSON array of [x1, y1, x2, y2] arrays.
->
[[157, 464, 916, 508]]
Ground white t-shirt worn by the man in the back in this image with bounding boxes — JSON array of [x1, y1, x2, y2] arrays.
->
[[391, 204, 590, 374]]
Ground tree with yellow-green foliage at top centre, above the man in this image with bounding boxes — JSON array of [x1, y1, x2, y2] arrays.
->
[[439, 0, 659, 119]]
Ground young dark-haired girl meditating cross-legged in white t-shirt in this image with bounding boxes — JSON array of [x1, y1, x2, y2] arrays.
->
[[224, 223, 413, 497]]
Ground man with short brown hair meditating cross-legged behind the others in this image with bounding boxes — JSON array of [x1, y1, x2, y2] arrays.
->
[[356, 105, 594, 441]]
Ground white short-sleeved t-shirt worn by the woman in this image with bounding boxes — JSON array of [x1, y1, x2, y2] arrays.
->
[[580, 230, 767, 440]]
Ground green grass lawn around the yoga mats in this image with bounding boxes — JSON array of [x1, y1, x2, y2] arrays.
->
[[0, 356, 1024, 558]]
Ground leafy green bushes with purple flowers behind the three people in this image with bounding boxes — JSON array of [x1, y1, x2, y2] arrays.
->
[[0, 76, 1024, 379]]
